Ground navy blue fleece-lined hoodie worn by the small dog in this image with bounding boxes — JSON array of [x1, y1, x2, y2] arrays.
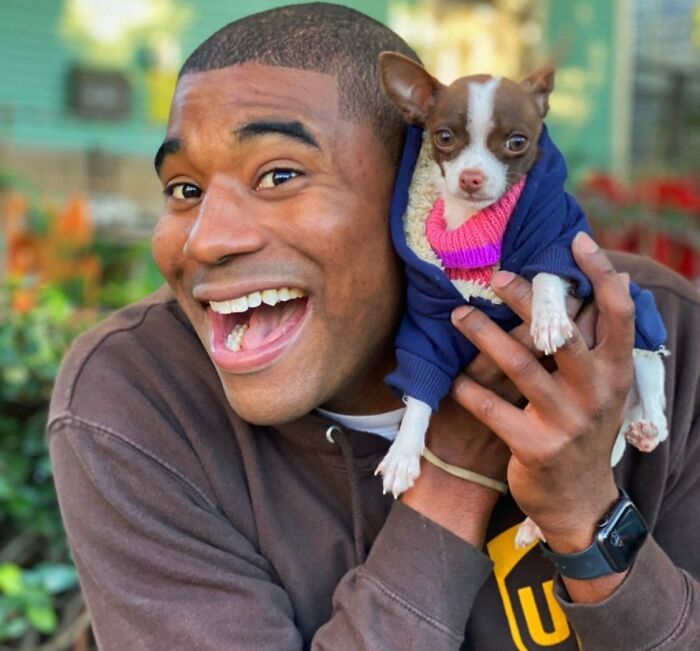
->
[[386, 126, 666, 410]]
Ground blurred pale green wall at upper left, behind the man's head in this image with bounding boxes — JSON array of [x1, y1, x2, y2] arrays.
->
[[0, 0, 388, 156]]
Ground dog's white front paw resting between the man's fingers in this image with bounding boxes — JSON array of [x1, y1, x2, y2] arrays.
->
[[530, 272, 574, 355]]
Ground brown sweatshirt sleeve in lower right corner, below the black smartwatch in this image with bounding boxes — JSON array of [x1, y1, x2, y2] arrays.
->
[[558, 416, 700, 651]]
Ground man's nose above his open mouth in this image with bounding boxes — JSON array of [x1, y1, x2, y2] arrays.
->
[[184, 187, 265, 265]]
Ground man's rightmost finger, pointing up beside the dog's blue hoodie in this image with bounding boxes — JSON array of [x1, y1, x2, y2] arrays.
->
[[572, 232, 634, 362]]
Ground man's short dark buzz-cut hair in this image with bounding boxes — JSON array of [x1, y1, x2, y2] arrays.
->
[[180, 2, 420, 162]]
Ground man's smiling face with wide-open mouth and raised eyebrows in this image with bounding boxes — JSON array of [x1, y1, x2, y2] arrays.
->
[[153, 63, 401, 423]]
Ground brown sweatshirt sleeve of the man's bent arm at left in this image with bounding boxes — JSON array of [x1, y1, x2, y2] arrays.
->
[[49, 417, 490, 651]]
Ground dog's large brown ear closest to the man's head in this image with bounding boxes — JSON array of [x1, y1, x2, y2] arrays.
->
[[379, 52, 444, 126]]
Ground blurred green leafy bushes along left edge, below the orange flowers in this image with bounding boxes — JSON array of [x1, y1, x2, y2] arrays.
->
[[0, 281, 96, 641]]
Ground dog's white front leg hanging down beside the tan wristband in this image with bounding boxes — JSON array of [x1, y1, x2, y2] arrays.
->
[[374, 397, 432, 497]]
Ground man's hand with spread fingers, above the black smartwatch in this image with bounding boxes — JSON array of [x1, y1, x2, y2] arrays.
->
[[453, 235, 634, 600]]
